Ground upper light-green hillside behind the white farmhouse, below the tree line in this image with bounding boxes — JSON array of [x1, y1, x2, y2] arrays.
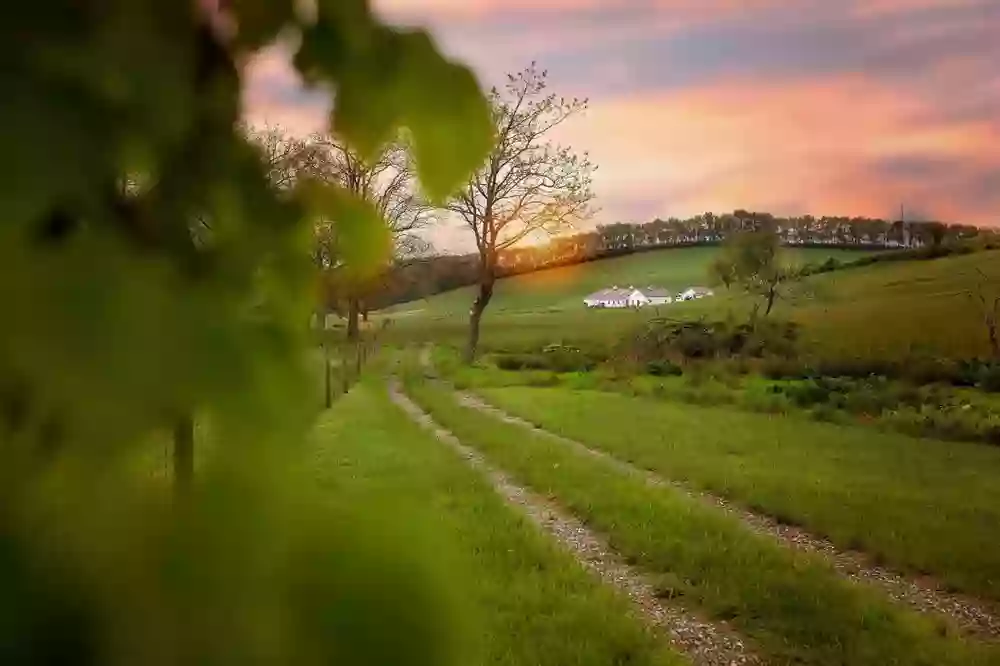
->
[[387, 247, 863, 315]]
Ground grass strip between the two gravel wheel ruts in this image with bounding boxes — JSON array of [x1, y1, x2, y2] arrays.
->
[[411, 384, 998, 666]]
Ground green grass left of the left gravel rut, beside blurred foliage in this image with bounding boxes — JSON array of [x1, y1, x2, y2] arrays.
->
[[312, 385, 685, 666]]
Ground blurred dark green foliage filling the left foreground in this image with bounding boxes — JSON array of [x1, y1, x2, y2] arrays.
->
[[0, 0, 492, 665]]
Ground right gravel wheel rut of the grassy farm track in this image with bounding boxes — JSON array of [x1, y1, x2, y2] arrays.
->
[[455, 391, 1000, 640]]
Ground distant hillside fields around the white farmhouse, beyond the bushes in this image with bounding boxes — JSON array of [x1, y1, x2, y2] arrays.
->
[[384, 248, 1000, 359]]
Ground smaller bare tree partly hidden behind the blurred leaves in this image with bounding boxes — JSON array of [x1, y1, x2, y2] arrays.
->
[[308, 136, 435, 340]]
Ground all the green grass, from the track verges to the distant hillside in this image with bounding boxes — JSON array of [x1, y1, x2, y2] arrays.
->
[[302, 248, 1000, 666]]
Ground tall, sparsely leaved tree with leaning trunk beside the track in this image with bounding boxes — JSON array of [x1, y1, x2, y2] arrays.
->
[[448, 63, 595, 362]]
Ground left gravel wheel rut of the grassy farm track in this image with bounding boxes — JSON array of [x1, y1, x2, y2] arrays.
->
[[389, 381, 760, 666]]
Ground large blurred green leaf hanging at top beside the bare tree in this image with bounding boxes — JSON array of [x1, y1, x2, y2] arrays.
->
[[296, 13, 494, 202]]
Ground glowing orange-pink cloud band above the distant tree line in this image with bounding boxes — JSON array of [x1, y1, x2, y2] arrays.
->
[[560, 75, 1000, 223]]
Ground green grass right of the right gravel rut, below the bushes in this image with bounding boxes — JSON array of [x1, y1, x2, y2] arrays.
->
[[472, 388, 1000, 601]]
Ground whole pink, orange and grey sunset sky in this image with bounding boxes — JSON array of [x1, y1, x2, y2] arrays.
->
[[244, 0, 1000, 251]]
